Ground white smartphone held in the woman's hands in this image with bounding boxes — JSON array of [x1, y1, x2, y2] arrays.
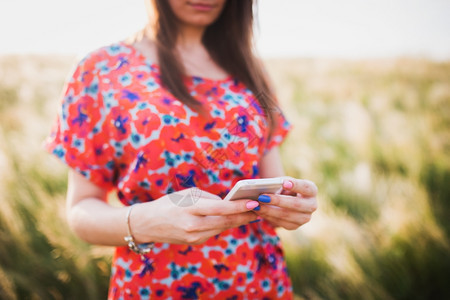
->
[[223, 177, 284, 200]]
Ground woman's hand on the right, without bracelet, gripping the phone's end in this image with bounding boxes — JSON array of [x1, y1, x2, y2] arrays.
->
[[254, 177, 317, 230]]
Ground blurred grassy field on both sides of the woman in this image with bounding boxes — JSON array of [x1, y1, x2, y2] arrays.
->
[[0, 55, 450, 300]]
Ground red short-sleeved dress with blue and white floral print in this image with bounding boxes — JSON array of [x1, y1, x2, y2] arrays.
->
[[46, 42, 292, 299]]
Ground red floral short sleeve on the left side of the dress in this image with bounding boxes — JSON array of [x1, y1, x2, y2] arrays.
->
[[44, 55, 115, 190]]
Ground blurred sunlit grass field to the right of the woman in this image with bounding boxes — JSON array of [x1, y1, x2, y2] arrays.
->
[[272, 60, 450, 299]]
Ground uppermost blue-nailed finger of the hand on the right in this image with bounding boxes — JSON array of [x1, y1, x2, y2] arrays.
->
[[258, 194, 317, 213]]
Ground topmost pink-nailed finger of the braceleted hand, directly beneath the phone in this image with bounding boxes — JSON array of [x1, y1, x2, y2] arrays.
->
[[189, 198, 259, 216]]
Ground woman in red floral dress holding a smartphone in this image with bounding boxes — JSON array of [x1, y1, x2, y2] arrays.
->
[[47, 0, 317, 299]]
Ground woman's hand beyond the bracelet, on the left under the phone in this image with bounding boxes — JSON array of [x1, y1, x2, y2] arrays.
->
[[130, 188, 259, 245]]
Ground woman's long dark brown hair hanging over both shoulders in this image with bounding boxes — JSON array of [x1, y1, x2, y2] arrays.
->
[[153, 0, 277, 132]]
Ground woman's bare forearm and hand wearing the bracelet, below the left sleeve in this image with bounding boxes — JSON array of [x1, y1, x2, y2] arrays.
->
[[67, 170, 258, 246]]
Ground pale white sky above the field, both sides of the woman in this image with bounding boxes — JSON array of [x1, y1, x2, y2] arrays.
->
[[0, 0, 450, 60]]
